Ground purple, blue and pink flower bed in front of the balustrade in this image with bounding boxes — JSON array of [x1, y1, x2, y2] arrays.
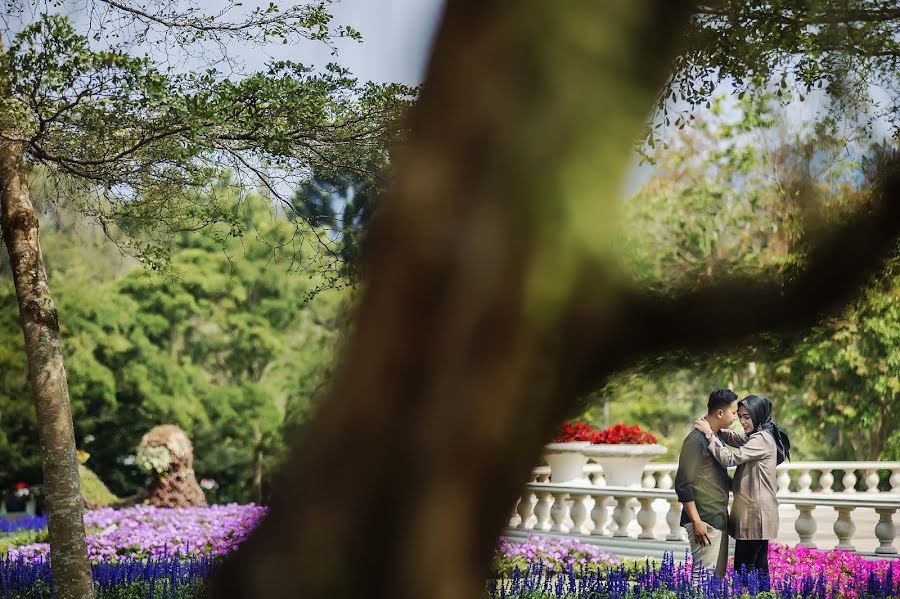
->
[[486, 535, 900, 599]]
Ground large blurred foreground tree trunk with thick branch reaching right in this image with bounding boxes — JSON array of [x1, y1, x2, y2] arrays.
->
[[212, 0, 897, 599]]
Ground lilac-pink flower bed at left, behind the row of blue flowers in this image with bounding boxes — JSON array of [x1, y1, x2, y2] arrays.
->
[[8, 505, 265, 562]]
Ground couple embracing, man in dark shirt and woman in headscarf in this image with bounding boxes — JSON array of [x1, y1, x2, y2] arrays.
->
[[675, 389, 791, 588]]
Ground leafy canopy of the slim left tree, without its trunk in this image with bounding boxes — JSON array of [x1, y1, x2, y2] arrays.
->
[[0, 11, 415, 278]]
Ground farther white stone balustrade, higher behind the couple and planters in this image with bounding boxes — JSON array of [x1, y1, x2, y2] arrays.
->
[[532, 462, 900, 495]]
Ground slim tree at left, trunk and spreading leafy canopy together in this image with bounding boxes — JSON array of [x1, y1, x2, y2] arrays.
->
[[0, 0, 410, 599]]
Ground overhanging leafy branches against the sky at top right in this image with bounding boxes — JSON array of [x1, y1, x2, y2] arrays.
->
[[647, 0, 900, 149]]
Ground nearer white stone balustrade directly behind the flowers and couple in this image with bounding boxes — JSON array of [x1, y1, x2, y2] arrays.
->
[[506, 482, 900, 558]]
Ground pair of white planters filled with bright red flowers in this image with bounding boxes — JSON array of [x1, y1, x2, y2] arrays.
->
[[544, 421, 666, 488]]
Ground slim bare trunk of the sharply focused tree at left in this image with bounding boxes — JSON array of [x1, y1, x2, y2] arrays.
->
[[0, 141, 94, 599]]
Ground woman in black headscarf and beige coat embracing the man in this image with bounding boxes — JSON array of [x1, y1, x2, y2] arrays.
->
[[694, 395, 791, 589]]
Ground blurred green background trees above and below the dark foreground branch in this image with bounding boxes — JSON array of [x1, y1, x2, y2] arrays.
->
[[585, 96, 900, 459]]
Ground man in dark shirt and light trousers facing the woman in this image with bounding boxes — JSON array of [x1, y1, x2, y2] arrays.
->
[[675, 389, 737, 586]]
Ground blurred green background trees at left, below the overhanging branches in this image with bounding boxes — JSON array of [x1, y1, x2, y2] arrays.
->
[[0, 188, 347, 502]]
